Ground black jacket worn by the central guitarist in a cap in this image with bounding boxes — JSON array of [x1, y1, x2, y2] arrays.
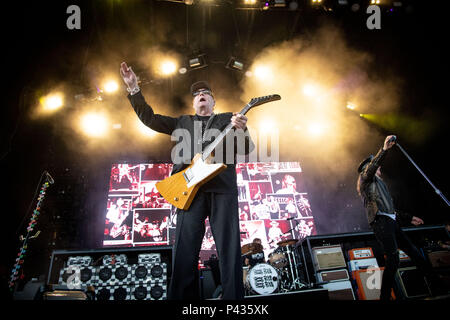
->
[[128, 92, 254, 194]]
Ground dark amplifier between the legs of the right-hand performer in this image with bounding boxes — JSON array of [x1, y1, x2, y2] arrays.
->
[[395, 267, 431, 299]]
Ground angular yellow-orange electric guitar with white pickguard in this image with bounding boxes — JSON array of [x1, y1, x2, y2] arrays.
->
[[155, 94, 281, 210]]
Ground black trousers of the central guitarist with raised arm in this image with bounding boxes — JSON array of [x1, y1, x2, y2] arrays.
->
[[168, 191, 244, 300]]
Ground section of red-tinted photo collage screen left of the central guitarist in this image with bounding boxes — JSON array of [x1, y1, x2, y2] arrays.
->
[[103, 163, 175, 246]]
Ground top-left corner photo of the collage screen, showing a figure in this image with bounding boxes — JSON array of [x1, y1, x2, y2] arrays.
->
[[109, 163, 140, 195]]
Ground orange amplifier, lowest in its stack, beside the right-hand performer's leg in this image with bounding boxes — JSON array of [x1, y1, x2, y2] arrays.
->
[[353, 267, 395, 300]]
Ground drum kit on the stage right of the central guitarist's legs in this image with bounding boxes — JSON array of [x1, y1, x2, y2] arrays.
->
[[241, 239, 307, 296]]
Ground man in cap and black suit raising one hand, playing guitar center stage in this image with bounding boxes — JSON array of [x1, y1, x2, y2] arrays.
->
[[120, 62, 254, 300]]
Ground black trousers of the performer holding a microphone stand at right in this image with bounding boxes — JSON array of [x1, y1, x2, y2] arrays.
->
[[371, 215, 431, 300]]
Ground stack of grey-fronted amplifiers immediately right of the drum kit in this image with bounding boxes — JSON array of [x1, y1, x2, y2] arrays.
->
[[312, 245, 355, 300]]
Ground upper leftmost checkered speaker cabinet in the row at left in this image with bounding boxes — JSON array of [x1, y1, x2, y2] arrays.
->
[[58, 266, 98, 289]]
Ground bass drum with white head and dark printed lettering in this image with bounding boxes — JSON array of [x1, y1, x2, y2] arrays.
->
[[245, 263, 280, 295]]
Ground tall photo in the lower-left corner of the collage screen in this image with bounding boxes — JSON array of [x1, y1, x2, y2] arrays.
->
[[103, 197, 132, 245]]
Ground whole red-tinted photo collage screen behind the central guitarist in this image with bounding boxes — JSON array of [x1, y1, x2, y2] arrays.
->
[[103, 162, 316, 263]]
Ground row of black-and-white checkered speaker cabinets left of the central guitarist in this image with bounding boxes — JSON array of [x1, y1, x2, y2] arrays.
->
[[58, 253, 167, 300]]
